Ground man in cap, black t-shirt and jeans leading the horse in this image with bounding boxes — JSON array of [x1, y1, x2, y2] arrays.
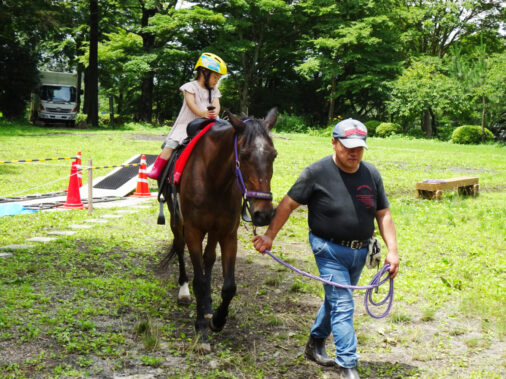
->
[[253, 119, 399, 378]]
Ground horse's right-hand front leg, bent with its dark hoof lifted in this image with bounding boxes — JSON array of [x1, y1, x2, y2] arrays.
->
[[209, 233, 237, 332]]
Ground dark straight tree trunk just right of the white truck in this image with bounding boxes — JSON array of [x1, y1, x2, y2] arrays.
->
[[86, 0, 98, 126]]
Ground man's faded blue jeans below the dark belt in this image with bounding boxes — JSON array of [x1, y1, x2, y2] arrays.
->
[[309, 233, 367, 368]]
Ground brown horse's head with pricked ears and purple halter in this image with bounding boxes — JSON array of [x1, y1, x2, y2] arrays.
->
[[228, 108, 278, 226]]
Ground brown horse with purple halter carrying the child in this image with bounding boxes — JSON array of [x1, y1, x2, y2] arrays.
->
[[163, 108, 277, 351]]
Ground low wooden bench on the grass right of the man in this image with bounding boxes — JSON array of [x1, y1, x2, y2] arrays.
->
[[416, 177, 480, 200]]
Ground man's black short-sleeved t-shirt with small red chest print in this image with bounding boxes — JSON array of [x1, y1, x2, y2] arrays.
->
[[288, 156, 389, 241]]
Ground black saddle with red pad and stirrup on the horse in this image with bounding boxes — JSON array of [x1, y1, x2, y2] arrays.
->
[[157, 118, 228, 227]]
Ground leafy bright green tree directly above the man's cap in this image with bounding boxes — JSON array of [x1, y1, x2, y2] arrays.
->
[[298, 0, 401, 120]]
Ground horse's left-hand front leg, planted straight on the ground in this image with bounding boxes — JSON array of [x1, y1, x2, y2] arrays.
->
[[185, 228, 211, 352]]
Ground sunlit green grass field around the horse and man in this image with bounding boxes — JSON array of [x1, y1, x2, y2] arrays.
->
[[0, 120, 506, 378]]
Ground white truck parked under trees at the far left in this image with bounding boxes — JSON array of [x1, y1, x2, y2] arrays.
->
[[30, 71, 79, 126]]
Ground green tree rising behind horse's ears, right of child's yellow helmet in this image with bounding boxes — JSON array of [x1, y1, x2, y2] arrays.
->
[[199, 0, 298, 114]]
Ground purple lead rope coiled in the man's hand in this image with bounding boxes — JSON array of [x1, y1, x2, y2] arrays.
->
[[264, 250, 394, 319]]
